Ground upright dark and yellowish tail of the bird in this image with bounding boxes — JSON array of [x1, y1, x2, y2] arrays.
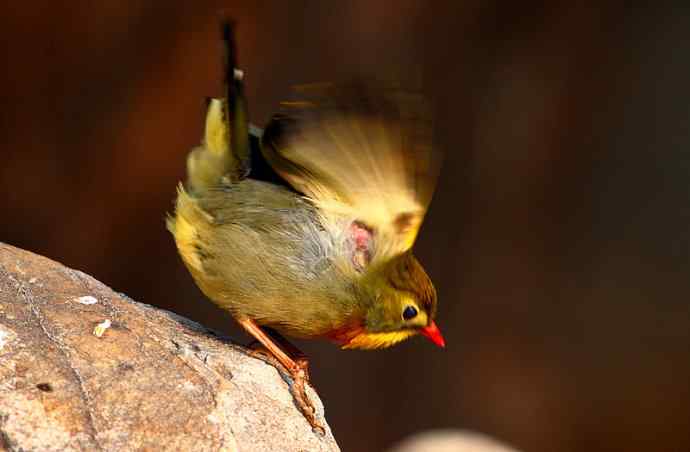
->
[[185, 21, 250, 194]]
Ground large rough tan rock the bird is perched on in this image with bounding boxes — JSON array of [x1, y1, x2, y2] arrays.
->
[[0, 243, 338, 451]]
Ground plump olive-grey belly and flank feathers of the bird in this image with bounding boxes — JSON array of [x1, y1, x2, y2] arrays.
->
[[169, 179, 364, 337]]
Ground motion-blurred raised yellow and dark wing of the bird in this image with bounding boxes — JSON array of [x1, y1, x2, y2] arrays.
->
[[262, 82, 439, 257]]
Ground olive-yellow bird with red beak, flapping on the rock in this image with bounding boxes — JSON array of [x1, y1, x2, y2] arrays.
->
[[167, 21, 445, 430]]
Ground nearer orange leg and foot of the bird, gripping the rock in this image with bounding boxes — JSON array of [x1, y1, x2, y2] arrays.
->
[[238, 319, 325, 432]]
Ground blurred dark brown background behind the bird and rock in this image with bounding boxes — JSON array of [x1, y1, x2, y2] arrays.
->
[[0, 0, 690, 452]]
